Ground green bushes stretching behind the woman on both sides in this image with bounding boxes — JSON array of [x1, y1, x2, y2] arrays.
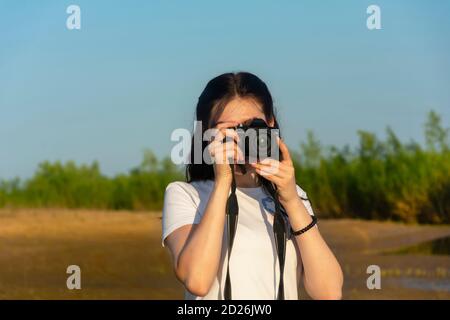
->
[[0, 112, 450, 223]]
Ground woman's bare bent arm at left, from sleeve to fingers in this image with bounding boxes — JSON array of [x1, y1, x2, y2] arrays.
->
[[166, 123, 242, 296]]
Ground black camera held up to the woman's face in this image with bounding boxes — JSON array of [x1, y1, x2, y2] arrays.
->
[[235, 118, 280, 163]]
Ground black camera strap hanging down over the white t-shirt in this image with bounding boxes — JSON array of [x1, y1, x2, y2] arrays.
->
[[224, 164, 286, 300]]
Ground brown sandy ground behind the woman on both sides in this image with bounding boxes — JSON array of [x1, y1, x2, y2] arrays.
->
[[0, 209, 450, 299]]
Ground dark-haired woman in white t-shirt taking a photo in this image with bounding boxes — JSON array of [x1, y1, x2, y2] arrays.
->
[[162, 72, 343, 299]]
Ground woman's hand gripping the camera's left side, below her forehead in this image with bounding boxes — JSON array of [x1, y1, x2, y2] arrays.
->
[[208, 122, 244, 184]]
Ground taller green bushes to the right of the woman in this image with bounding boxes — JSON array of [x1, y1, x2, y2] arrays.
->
[[295, 112, 450, 223]]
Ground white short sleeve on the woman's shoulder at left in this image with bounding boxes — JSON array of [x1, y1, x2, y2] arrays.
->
[[162, 182, 200, 247]]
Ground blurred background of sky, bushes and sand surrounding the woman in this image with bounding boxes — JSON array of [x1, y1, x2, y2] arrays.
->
[[0, 0, 450, 299]]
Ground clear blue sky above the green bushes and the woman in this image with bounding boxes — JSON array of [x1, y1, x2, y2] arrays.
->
[[0, 0, 450, 178]]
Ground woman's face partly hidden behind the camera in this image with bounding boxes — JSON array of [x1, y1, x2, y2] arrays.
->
[[216, 98, 274, 176]]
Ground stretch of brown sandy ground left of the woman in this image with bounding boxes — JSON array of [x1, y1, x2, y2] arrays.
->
[[0, 210, 182, 299]]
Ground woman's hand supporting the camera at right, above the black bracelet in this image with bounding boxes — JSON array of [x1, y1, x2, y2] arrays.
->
[[251, 138, 298, 205]]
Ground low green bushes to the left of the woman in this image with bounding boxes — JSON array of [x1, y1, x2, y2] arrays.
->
[[0, 151, 183, 210]]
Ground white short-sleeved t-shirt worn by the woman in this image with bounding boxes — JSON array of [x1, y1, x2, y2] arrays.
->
[[162, 180, 314, 300]]
